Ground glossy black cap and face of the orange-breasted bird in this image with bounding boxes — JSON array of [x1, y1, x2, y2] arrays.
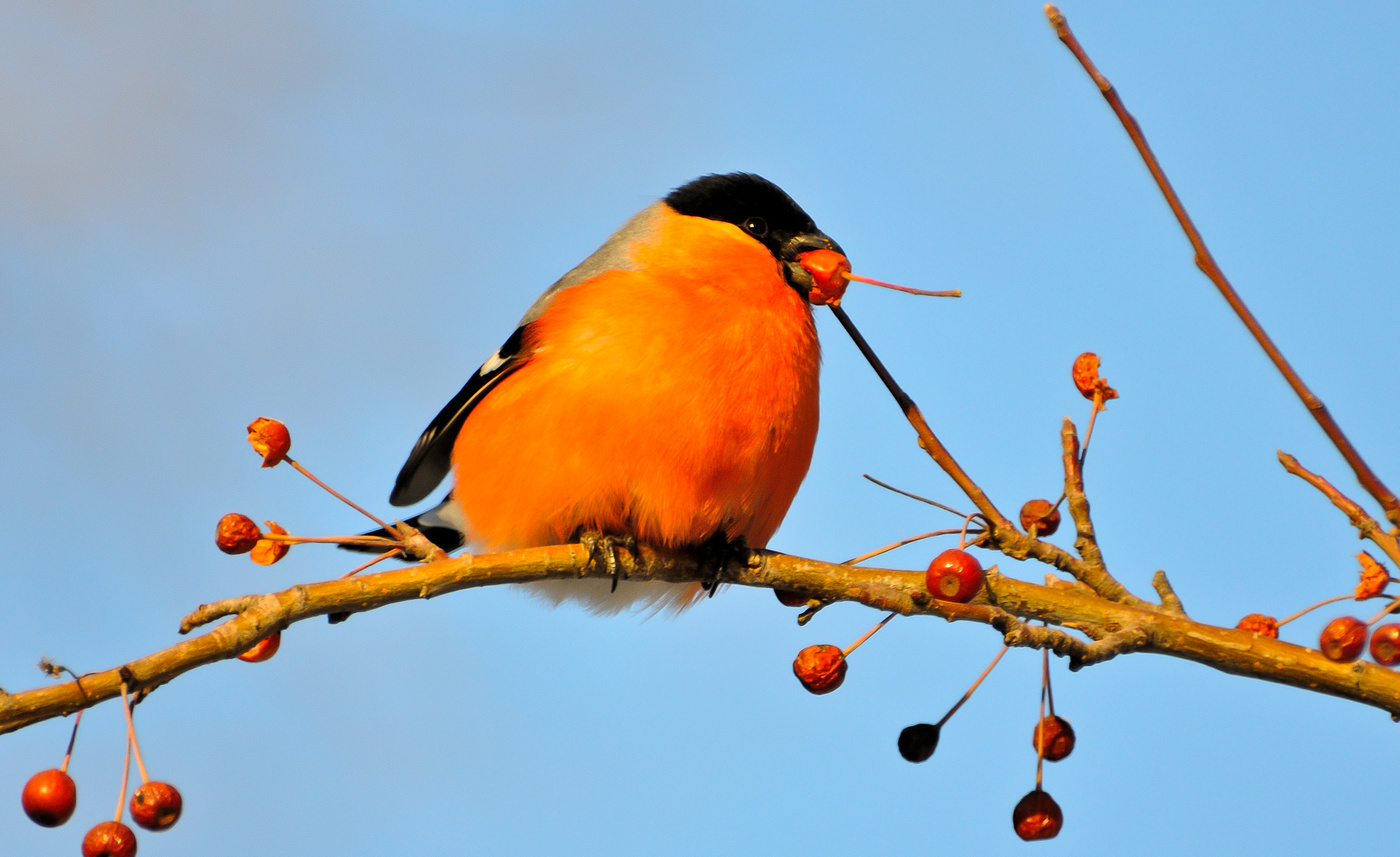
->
[[665, 172, 841, 262]]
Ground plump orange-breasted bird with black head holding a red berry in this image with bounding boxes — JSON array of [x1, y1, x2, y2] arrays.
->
[[375, 172, 844, 613]]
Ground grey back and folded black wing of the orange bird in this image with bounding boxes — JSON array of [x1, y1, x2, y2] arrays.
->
[[389, 203, 665, 506]]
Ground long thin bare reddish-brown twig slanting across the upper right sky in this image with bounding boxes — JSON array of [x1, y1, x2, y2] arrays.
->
[[1046, 4, 1400, 527]]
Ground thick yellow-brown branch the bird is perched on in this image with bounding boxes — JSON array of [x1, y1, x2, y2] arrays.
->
[[10, 545, 1400, 734]]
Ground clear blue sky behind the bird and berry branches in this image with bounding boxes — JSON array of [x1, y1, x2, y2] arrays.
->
[[0, 0, 1400, 857]]
